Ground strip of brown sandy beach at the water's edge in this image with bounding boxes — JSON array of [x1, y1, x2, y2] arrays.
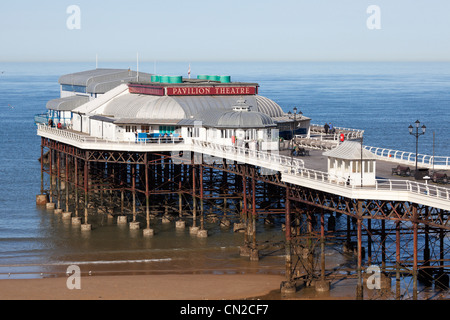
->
[[0, 274, 284, 300]]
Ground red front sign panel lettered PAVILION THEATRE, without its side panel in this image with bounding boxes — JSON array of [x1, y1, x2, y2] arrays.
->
[[166, 86, 258, 96]]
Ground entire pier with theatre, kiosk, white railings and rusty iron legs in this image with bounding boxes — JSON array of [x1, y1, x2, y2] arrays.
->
[[36, 70, 450, 299]]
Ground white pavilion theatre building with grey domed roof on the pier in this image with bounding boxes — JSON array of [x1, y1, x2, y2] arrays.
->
[[36, 69, 310, 150]]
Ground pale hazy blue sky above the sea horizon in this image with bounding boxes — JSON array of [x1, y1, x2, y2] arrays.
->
[[0, 0, 450, 62]]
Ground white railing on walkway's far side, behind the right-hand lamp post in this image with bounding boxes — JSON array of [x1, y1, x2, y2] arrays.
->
[[364, 146, 450, 169]]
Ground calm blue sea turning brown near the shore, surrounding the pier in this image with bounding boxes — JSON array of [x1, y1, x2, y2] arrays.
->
[[0, 62, 450, 278]]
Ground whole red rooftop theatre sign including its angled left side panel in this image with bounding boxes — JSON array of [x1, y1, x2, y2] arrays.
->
[[128, 84, 258, 96]]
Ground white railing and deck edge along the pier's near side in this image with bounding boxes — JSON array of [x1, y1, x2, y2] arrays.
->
[[38, 125, 450, 212]]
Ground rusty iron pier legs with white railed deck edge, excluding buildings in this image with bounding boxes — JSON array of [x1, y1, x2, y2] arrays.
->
[[38, 125, 450, 298]]
